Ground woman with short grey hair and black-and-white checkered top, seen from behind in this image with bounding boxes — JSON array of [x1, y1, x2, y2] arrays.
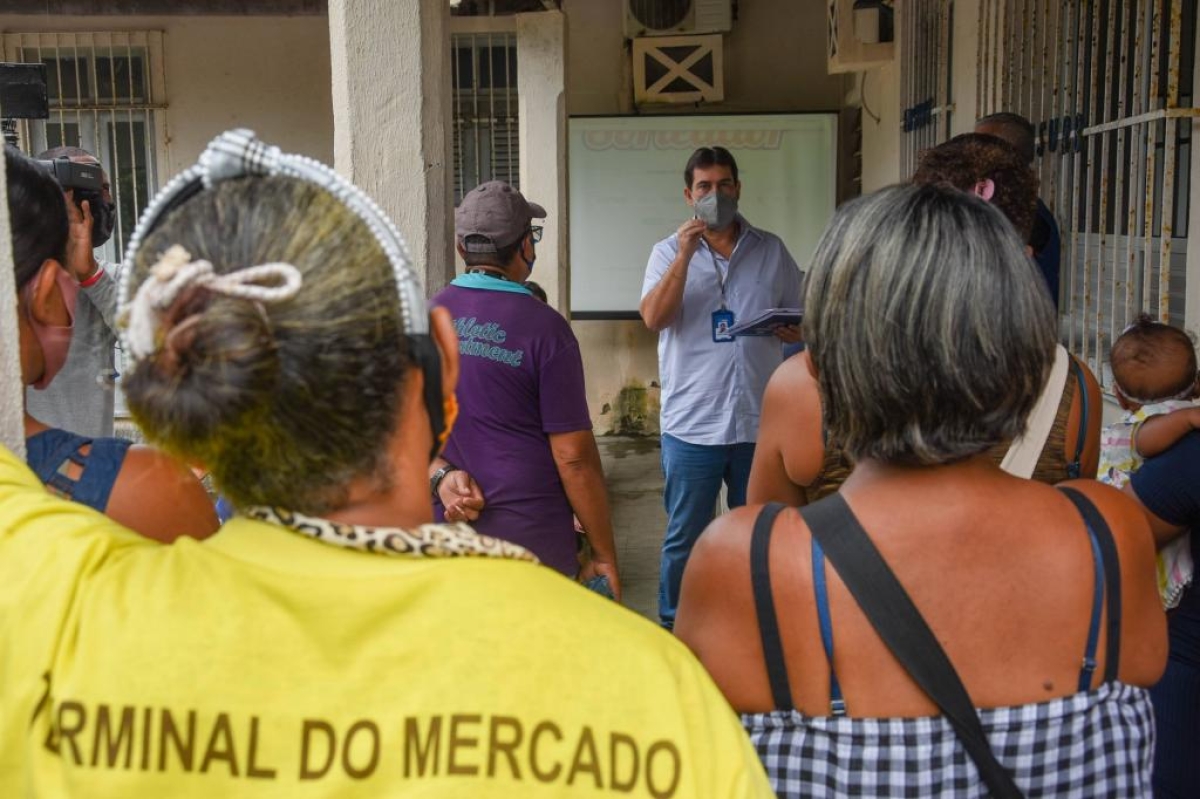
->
[[676, 186, 1165, 797]]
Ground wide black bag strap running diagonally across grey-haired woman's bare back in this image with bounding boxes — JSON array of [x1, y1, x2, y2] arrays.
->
[[800, 494, 1022, 799]]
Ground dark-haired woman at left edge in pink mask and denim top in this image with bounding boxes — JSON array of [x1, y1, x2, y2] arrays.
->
[[5, 146, 217, 541]]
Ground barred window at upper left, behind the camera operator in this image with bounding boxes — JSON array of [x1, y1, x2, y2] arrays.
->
[[4, 31, 166, 262]]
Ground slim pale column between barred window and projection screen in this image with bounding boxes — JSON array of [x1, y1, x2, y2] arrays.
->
[[517, 11, 571, 314]]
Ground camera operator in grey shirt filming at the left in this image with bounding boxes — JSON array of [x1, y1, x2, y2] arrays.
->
[[25, 148, 120, 437]]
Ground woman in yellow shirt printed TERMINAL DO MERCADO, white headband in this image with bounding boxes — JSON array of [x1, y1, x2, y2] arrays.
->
[[0, 131, 770, 799]]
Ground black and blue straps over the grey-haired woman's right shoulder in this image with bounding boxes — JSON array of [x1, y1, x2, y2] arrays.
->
[[1060, 488, 1121, 691]]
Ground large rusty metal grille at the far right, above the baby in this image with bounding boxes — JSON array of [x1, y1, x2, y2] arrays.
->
[[978, 0, 1198, 386]]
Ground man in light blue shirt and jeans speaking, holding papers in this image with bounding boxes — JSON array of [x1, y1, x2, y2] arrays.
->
[[640, 148, 803, 629]]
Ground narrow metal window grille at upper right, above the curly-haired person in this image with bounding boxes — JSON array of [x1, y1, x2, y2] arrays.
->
[[896, 0, 954, 178]]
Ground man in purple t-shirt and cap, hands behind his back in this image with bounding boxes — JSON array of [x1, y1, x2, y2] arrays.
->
[[430, 181, 620, 590]]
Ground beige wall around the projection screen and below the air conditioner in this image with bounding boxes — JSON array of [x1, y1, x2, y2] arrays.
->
[[563, 0, 847, 434]]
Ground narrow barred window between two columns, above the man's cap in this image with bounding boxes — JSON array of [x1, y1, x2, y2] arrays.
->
[[451, 32, 520, 205]]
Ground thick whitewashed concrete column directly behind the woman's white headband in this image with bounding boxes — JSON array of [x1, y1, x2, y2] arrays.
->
[[329, 0, 454, 294]]
